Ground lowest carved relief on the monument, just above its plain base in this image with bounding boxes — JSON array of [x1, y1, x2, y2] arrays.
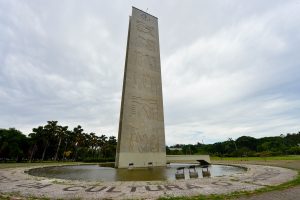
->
[[123, 125, 165, 153]]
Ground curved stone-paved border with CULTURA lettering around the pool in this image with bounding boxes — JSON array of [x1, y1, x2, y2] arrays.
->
[[0, 165, 297, 199]]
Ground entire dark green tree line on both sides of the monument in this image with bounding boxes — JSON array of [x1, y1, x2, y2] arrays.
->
[[0, 121, 300, 162]]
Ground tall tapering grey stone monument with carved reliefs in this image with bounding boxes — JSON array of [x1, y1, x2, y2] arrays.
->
[[115, 7, 166, 168]]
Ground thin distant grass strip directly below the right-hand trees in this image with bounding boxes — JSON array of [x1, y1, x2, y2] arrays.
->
[[210, 155, 300, 161]]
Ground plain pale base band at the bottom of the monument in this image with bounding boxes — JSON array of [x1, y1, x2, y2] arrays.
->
[[115, 152, 166, 168]]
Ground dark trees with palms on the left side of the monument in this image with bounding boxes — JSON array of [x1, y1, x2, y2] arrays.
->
[[0, 121, 117, 162]]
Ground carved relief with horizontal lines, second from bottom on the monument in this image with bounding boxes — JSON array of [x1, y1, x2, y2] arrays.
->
[[130, 96, 163, 121]]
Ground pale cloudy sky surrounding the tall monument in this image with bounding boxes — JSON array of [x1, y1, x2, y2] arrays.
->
[[0, 0, 300, 145]]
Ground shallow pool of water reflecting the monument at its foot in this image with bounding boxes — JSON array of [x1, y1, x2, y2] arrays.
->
[[28, 163, 245, 181]]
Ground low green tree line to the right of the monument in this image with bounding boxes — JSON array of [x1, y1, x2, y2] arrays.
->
[[167, 132, 300, 157]]
